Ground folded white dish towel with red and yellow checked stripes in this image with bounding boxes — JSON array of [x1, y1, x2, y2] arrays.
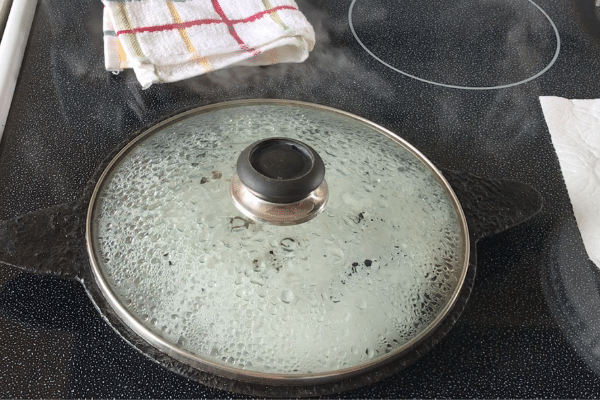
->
[[103, 0, 315, 88]]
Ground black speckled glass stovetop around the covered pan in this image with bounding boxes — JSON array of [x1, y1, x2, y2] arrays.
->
[[0, 0, 600, 398]]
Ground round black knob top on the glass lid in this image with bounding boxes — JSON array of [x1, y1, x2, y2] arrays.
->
[[237, 138, 325, 203]]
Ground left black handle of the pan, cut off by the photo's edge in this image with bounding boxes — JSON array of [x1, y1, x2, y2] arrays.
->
[[0, 199, 88, 280]]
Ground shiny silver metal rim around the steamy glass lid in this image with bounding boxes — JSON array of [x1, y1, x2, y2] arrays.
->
[[86, 99, 470, 386]]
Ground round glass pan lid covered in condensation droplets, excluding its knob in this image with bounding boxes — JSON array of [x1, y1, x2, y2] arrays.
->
[[87, 101, 469, 379]]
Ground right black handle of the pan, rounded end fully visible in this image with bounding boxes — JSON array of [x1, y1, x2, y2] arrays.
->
[[442, 170, 542, 241]]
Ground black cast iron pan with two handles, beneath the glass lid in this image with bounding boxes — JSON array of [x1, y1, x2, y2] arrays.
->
[[0, 101, 542, 397]]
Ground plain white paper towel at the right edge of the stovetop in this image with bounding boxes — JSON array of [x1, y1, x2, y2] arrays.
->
[[540, 97, 600, 267]]
